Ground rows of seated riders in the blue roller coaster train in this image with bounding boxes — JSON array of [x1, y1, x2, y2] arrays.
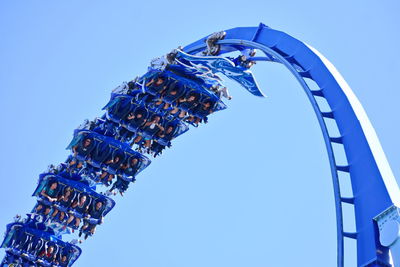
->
[[3, 51, 231, 266]]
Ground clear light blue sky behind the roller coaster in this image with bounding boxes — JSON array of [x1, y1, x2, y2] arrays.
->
[[0, 0, 400, 267]]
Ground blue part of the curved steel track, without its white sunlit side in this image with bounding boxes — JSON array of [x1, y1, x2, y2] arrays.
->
[[184, 24, 398, 267]]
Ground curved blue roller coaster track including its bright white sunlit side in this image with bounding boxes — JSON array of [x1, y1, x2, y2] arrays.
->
[[1, 24, 400, 267]]
